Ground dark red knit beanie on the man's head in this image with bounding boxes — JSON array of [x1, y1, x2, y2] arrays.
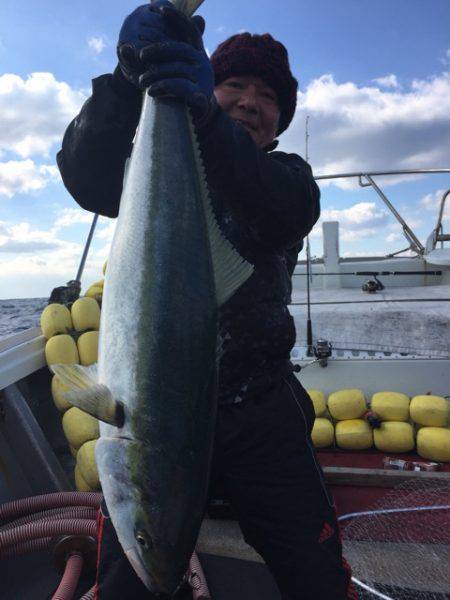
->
[[211, 33, 298, 135]]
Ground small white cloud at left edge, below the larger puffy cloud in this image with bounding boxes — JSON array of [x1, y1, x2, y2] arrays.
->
[[0, 158, 60, 198]]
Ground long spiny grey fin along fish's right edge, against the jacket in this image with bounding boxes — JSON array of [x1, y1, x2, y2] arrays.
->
[[188, 113, 254, 306]]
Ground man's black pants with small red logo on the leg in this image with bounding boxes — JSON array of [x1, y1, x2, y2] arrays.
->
[[97, 375, 357, 600]]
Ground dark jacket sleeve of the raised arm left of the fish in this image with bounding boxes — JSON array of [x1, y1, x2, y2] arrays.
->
[[56, 70, 142, 217]]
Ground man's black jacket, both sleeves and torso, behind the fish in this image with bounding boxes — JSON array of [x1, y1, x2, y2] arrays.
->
[[57, 75, 320, 403]]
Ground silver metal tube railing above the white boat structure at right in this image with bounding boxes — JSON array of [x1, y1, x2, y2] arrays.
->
[[315, 168, 450, 256]]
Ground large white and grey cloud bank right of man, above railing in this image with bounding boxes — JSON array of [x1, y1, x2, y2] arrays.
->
[[280, 73, 450, 188]]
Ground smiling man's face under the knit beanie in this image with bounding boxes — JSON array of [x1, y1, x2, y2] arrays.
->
[[214, 75, 280, 148]]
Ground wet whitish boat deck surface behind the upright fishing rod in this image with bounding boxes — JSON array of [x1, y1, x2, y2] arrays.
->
[[290, 285, 450, 357]]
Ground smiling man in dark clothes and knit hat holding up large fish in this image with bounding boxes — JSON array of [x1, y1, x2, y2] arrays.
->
[[58, 0, 355, 600]]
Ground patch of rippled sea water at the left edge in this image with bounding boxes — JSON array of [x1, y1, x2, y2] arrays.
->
[[0, 298, 48, 339]]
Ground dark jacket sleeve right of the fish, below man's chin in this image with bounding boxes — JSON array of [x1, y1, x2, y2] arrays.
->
[[198, 107, 320, 249]]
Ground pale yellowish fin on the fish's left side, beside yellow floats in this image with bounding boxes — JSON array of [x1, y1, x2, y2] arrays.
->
[[50, 365, 124, 427]]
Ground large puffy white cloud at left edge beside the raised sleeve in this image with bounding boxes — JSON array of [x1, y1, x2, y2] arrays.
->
[[0, 73, 86, 158]]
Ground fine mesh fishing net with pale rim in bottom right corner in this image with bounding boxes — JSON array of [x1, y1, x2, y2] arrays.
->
[[340, 479, 450, 600]]
